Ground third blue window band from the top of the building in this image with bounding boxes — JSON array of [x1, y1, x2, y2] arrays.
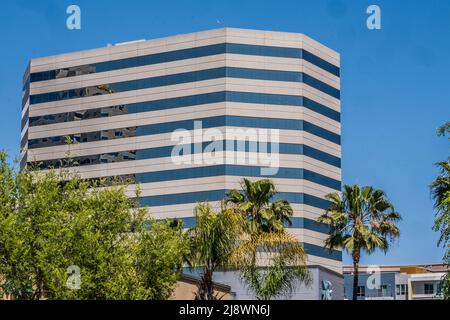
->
[[28, 91, 341, 127]]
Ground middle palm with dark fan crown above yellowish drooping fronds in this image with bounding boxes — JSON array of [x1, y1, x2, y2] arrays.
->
[[225, 179, 310, 300]]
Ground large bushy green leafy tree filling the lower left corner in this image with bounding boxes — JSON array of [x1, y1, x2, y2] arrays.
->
[[0, 153, 187, 299]]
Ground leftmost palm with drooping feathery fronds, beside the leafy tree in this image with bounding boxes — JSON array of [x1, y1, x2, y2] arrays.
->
[[185, 203, 243, 300]]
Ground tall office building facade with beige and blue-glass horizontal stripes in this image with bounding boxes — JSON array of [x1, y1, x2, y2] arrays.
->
[[21, 28, 342, 273]]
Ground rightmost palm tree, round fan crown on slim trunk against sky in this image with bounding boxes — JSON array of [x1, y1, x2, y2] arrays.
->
[[318, 185, 401, 300]]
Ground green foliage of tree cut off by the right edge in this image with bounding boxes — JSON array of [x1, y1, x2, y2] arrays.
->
[[431, 122, 450, 299]]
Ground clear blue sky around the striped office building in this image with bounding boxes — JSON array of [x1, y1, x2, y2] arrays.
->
[[0, 0, 450, 264]]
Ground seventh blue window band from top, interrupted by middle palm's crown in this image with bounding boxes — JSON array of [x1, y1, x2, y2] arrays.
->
[[138, 189, 330, 210]]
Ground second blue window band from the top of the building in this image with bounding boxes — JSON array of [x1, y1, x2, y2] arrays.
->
[[30, 67, 340, 104]]
